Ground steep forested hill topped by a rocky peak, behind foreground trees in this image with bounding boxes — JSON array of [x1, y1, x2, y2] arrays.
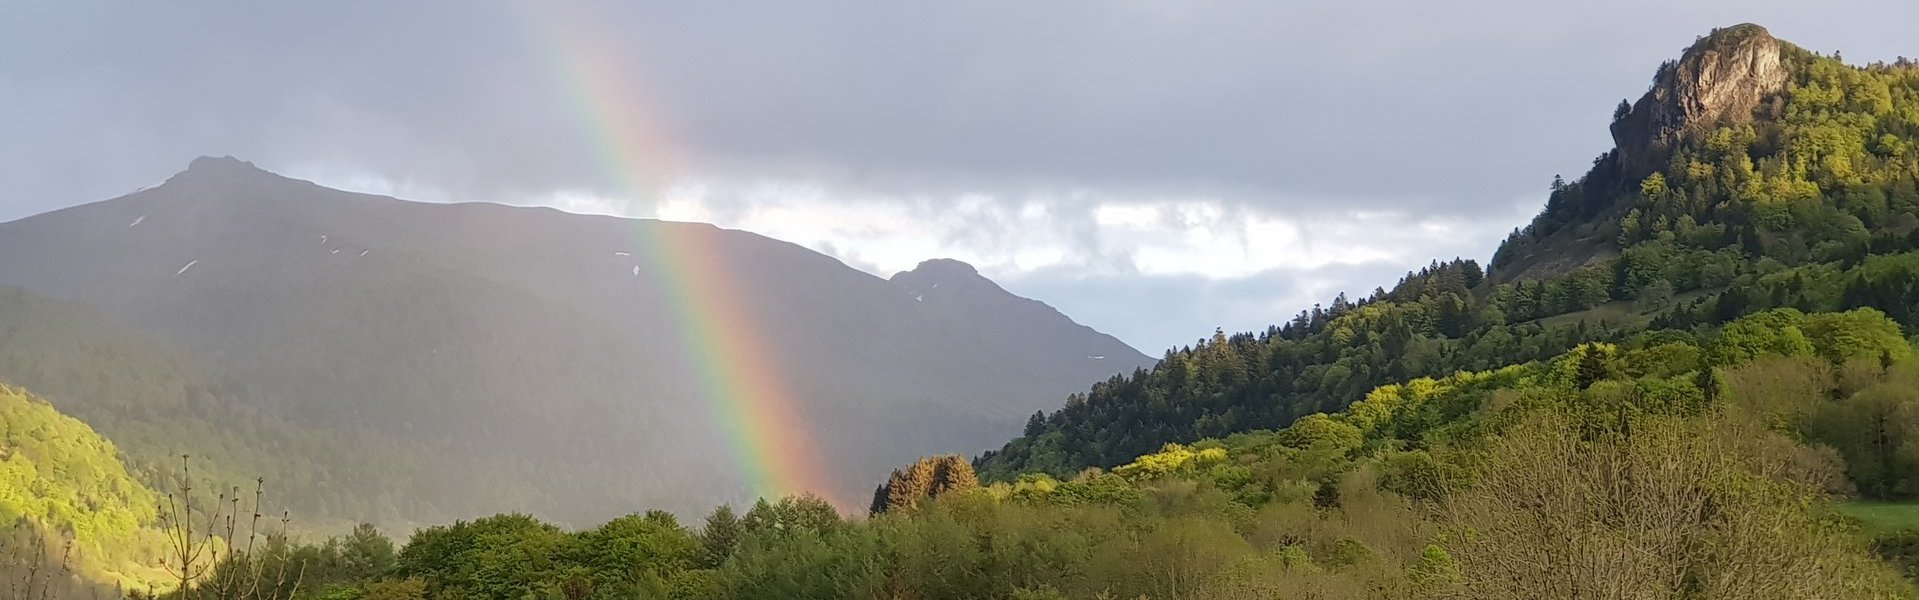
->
[[977, 25, 1919, 481]]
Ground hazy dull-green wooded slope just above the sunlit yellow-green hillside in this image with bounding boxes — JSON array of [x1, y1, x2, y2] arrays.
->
[[0, 286, 432, 529]]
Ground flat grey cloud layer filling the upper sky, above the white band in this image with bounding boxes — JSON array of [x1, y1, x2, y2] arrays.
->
[[0, 0, 1919, 350]]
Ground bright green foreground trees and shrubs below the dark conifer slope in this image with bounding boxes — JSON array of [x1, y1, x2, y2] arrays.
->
[[123, 309, 1919, 600]]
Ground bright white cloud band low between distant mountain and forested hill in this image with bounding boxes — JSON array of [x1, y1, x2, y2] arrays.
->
[[518, 180, 1535, 351]]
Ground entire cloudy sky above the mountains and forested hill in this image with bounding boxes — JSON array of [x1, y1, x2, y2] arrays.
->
[[0, 0, 1919, 355]]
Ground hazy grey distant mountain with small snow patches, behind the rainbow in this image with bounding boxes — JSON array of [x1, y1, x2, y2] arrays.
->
[[0, 157, 1151, 519]]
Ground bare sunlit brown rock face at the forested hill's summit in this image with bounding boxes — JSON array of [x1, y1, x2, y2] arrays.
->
[[1612, 23, 1787, 176]]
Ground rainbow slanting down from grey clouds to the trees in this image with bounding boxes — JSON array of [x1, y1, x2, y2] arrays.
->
[[526, 2, 846, 506]]
